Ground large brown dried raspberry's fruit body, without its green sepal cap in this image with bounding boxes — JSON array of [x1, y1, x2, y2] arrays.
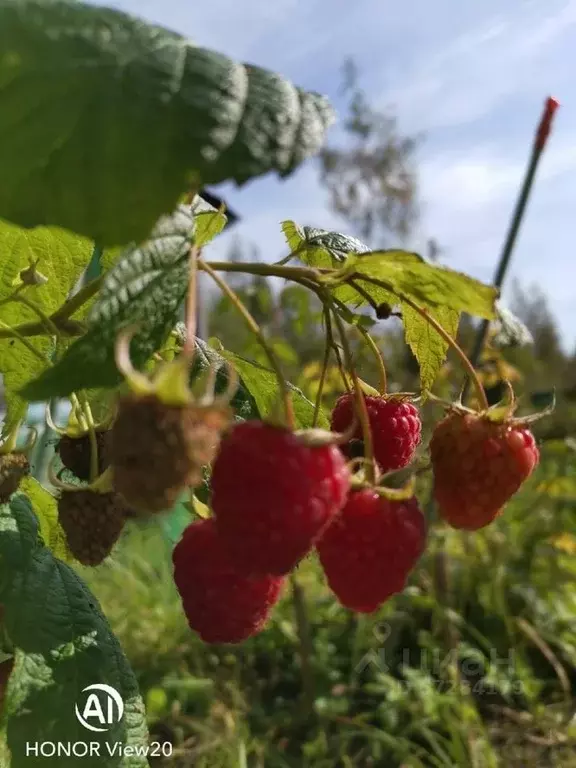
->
[[110, 395, 228, 512]]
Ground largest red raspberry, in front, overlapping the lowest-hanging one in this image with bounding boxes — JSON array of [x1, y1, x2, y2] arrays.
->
[[211, 421, 350, 576]]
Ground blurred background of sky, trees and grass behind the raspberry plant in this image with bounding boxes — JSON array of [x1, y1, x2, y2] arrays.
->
[[3, 0, 576, 768]]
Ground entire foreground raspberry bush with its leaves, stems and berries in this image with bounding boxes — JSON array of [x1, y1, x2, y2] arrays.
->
[[0, 0, 552, 768]]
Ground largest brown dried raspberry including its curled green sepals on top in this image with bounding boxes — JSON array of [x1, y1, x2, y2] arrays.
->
[[110, 328, 238, 513]]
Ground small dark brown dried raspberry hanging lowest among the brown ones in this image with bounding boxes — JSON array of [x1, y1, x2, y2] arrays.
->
[[58, 488, 128, 566]]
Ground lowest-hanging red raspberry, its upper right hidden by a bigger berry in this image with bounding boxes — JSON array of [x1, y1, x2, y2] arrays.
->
[[172, 518, 283, 643]]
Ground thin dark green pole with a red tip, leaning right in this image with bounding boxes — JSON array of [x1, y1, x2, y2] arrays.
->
[[462, 96, 560, 402]]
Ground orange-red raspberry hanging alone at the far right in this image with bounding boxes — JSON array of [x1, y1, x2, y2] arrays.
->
[[430, 411, 540, 531]]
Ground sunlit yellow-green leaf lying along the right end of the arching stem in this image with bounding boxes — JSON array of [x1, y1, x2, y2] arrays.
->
[[345, 250, 498, 320]]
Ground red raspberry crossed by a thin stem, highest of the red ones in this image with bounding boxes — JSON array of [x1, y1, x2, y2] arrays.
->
[[330, 393, 422, 472]]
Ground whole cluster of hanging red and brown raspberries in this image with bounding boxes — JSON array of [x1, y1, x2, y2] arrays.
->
[[41, 344, 539, 643]]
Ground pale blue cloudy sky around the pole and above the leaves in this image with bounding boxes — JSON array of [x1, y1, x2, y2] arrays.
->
[[108, 0, 576, 348]]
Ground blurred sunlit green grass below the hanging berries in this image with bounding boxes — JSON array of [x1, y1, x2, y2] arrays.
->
[[83, 444, 576, 768]]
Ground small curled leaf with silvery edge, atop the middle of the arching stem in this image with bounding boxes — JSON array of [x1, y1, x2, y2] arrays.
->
[[282, 221, 370, 269]]
